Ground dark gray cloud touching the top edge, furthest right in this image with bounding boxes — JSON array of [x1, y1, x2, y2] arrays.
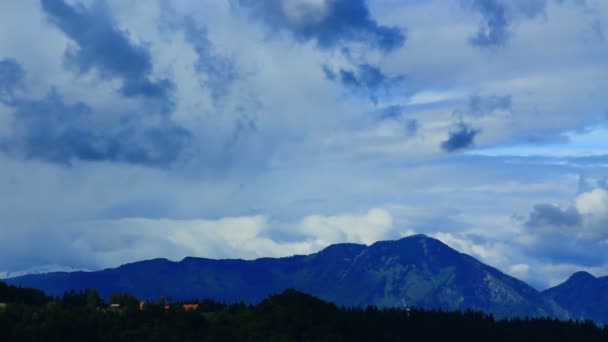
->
[[466, 0, 547, 47]]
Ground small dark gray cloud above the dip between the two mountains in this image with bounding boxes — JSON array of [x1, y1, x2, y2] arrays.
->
[[525, 204, 583, 229]]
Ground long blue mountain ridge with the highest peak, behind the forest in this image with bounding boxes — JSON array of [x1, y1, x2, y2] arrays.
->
[[6, 235, 568, 318]]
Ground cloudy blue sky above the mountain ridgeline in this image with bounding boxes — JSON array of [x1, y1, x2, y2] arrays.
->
[[0, 0, 608, 289]]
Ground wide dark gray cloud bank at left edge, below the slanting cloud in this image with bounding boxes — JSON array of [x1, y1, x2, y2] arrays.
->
[[0, 90, 190, 166]]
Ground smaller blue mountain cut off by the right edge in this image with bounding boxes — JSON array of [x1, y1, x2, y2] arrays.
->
[[543, 272, 608, 324]]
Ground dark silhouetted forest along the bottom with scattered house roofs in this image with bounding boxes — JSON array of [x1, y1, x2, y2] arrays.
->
[[0, 282, 608, 342]]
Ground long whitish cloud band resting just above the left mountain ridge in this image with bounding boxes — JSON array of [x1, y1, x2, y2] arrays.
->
[[0, 208, 398, 272]]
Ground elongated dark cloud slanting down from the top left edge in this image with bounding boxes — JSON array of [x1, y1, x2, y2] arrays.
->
[[41, 0, 173, 111]]
